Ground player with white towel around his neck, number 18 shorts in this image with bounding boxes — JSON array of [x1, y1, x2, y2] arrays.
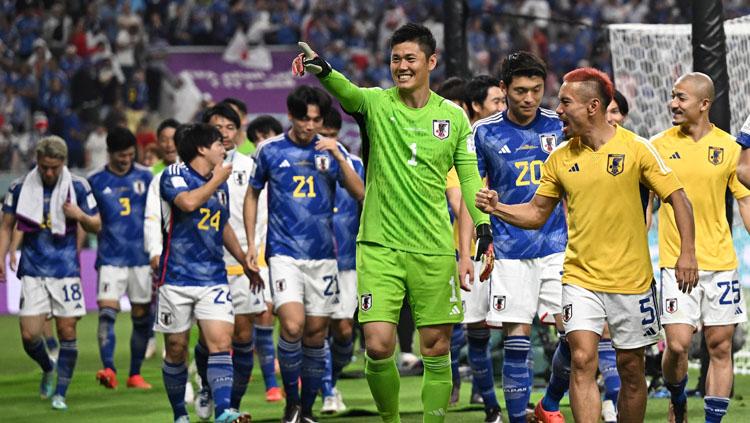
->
[[0, 136, 101, 410]]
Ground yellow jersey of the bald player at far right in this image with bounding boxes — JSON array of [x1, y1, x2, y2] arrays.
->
[[651, 126, 750, 270]]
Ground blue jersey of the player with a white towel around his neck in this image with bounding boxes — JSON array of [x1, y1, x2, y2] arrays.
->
[[3, 175, 97, 278]]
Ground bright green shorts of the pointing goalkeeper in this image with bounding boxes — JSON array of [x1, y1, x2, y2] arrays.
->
[[357, 243, 464, 327]]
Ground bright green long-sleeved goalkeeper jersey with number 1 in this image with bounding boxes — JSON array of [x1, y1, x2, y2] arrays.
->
[[320, 70, 489, 255]]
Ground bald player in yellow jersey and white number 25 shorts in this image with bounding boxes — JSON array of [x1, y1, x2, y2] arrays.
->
[[651, 72, 750, 422]]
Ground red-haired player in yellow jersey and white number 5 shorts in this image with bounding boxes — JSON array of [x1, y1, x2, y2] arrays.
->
[[476, 68, 698, 423]]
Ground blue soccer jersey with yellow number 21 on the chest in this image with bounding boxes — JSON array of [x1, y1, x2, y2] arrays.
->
[[250, 134, 348, 260]]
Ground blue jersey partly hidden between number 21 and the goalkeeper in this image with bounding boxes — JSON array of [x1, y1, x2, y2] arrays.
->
[[333, 154, 365, 271]]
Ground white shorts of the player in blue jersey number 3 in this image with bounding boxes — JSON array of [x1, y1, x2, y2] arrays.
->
[[96, 265, 151, 304]]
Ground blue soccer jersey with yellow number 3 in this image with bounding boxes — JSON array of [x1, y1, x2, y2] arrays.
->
[[88, 164, 153, 268]]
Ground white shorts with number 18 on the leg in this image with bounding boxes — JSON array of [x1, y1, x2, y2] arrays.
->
[[18, 276, 86, 317]]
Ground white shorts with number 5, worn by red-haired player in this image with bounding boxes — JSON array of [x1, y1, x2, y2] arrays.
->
[[562, 283, 661, 349]]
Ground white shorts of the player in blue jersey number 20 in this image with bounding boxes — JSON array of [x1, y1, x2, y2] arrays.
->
[[487, 253, 565, 326]]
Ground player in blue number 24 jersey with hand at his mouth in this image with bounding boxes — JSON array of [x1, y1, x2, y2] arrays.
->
[[154, 124, 262, 423]]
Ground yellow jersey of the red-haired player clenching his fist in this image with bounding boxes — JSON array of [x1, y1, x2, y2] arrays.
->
[[536, 126, 681, 294]]
